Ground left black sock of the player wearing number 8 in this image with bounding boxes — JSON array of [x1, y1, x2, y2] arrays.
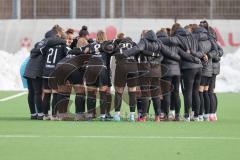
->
[[87, 91, 96, 117]]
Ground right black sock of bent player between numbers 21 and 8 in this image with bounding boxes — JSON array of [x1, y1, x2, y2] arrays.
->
[[75, 93, 85, 113]]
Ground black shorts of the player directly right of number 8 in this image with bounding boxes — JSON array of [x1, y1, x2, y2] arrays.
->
[[114, 62, 139, 87]]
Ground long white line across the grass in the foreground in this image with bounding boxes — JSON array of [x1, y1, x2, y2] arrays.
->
[[0, 135, 240, 142]]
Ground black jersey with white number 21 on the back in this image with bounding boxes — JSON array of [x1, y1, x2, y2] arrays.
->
[[41, 38, 70, 78]]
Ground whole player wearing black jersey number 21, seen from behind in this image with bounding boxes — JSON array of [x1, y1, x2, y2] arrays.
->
[[40, 28, 70, 119]]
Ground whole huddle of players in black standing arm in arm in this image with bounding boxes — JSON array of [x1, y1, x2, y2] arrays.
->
[[23, 21, 223, 122]]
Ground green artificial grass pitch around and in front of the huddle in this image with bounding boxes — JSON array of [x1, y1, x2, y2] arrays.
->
[[0, 92, 240, 160]]
